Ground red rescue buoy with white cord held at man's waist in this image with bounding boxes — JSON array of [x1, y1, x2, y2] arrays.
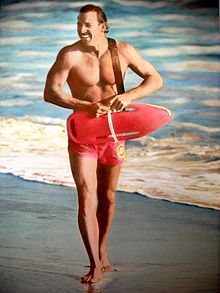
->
[[67, 104, 173, 144]]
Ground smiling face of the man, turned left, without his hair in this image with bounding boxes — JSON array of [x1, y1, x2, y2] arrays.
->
[[77, 11, 104, 46]]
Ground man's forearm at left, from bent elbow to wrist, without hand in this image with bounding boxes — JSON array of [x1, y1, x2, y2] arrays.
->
[[44, 88, 91, 111]]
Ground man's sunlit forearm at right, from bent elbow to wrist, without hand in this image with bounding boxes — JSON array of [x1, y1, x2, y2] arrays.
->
[[126, 74, 163, 101]]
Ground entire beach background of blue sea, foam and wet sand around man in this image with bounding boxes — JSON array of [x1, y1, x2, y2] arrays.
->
[[0, 0, 220, 293]]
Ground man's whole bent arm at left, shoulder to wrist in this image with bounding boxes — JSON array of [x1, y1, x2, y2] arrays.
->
[[44, 49, 91, 110]]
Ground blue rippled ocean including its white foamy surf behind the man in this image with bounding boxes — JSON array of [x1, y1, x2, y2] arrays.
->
[[0, 0, 220, 209]]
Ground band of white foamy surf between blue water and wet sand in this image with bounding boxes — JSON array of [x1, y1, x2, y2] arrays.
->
[[0, 117, 220, 210]]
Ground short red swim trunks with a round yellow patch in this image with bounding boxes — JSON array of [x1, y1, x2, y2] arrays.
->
[[68, 141, 125, 166]]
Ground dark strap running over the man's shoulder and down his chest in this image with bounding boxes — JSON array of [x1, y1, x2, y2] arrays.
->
[[108, 38, 125, 94]]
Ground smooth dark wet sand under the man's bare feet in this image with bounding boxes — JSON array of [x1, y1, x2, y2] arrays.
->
[[0, 174, 220, 293]]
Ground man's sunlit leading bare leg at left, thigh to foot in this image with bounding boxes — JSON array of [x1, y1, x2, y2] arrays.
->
[[69, 151, 102, 283]]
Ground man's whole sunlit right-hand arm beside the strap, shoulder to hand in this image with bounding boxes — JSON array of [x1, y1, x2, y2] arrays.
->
[[111, 43, 163, 110]]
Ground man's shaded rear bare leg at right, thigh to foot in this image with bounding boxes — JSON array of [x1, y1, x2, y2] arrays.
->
[[97, 165, 121, 272]]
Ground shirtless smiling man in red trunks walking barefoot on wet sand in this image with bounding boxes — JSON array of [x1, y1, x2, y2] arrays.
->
[[44, 5, 163, 283]]
